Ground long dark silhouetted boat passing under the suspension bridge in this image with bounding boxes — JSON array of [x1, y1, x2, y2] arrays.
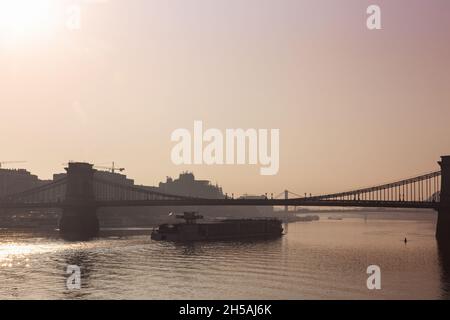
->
[[151, 212, 283, 241]]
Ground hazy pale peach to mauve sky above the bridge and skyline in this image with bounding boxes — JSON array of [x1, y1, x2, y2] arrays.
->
[[0, 0, 450, 194]]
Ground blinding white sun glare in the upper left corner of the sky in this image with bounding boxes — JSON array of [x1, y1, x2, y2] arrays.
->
[[0, 0, 56, 42]]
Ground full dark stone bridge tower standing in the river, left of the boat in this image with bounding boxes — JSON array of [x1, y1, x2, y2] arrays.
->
[[59, 162, 99, 240]]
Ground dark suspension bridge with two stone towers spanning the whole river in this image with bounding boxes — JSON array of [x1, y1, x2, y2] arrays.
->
[[0, 156, 450, 239]]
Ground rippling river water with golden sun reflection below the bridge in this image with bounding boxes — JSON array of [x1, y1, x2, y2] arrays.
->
[[0, 212, 450, 299]]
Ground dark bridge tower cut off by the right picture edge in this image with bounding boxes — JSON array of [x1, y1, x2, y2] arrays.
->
[[436, 156, 450, 242]]
